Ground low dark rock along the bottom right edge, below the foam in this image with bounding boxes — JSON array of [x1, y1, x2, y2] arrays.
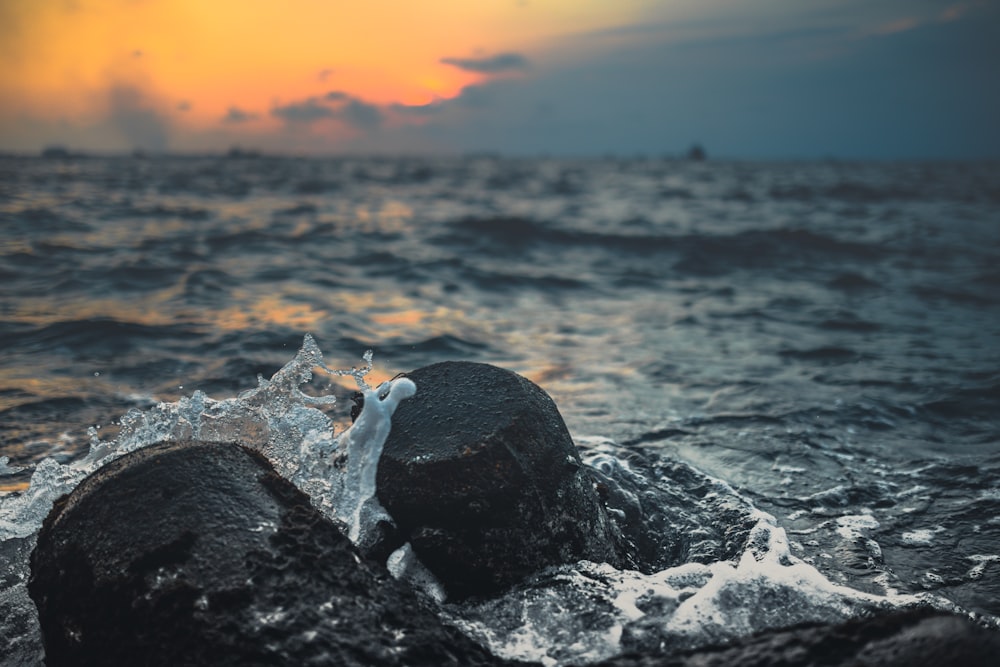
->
[[594, 610, 1000, 667]]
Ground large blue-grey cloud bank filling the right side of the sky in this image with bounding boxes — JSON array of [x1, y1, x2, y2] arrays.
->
[[409, 1, 1000, 158]]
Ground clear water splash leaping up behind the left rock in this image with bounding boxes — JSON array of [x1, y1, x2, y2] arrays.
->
[[0, 334, 416, 541]]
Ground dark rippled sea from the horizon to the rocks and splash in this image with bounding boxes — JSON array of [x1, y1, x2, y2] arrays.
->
[[0, 157, 1000, 664]]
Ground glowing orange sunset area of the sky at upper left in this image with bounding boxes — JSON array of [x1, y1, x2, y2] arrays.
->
[[0, 0, 638, 151]]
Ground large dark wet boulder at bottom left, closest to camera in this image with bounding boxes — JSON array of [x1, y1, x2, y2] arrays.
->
[[28, 442, 516, 667]]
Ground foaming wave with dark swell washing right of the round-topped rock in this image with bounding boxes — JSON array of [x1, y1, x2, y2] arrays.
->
[[444, 438, 961, 667]]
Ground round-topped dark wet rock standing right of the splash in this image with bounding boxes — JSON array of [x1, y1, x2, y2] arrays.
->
[[377, 362, 622, 599]]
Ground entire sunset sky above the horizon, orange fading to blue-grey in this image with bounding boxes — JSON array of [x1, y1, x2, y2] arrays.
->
[[0, 0, 1000, 159]]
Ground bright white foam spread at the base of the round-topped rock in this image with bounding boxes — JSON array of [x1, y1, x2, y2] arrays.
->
[[451, 511, 932, 665]]
